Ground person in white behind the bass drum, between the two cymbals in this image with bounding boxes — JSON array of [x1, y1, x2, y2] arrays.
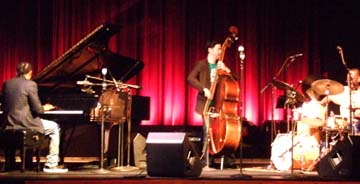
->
[[297, 75, 326, 144]]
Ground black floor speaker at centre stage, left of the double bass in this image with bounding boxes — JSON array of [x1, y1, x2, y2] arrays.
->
[[146, 132, 202, 177]]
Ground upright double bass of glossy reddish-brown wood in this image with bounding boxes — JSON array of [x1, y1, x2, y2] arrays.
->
[[203, 26, 241, 154]]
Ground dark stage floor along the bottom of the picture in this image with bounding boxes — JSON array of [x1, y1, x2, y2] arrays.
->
[[0, 159, 360, 184]]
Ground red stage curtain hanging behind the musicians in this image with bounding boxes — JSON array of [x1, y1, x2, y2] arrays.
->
[[0, 0, 319, 126]]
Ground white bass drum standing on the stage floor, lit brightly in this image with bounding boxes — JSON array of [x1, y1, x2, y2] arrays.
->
[[271, 133, 320, 171]]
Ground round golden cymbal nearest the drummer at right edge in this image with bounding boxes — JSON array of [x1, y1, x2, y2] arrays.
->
[[311, 79, 344, 95]]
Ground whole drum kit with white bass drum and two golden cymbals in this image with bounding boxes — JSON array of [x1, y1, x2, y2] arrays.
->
[[271, 79, 350, 171]]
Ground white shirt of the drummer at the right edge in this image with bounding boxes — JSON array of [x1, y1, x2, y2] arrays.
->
[[329, 86, 360, 118]]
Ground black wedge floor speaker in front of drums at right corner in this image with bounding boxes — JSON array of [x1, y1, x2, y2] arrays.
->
[[315, 136, 360, 178]]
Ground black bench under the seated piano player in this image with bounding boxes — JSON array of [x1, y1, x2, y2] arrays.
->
[[0, 129, 48, 172]]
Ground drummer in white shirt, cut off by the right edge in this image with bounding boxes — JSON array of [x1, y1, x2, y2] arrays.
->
[[323, 68, 360, 134]]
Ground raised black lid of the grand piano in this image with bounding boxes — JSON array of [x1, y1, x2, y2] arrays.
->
[[33, 24, 144, 92]]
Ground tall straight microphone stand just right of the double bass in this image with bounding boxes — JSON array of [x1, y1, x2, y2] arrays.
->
[[230, 46, 252, 179]]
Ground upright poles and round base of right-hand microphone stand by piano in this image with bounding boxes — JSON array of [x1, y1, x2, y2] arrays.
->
[[111, 86, 139, 171]]
